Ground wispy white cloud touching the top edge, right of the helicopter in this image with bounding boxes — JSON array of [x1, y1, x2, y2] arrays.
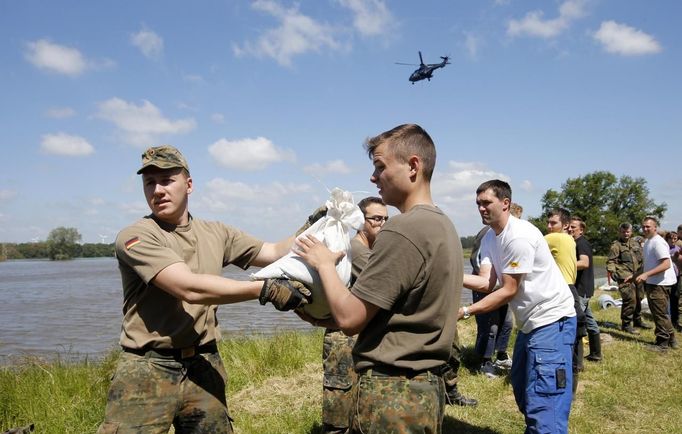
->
[[507, 0, 586, 38]]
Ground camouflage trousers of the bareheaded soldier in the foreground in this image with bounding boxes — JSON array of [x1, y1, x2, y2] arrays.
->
[[350, 369, 445, 434]]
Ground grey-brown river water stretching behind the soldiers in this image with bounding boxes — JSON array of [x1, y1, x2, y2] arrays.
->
[[0, 258, 471, 364]]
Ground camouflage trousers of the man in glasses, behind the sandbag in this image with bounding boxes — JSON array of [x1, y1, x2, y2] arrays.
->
[[322, 329, 357, 434]]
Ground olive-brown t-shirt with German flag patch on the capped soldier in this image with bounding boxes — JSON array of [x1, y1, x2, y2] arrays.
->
[[116, 216, 263, 349]]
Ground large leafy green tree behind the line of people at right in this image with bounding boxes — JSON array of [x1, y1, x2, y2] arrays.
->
[[529, 171, 668, 255]]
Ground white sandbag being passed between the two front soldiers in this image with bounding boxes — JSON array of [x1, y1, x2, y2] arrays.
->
[[251, 188, 365, 319]]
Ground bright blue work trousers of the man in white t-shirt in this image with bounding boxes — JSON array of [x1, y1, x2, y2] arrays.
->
[[511, 317, 576, 434]]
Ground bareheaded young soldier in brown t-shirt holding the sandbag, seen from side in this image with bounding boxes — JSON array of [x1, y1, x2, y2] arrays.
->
[[297, 124, 463, 434]]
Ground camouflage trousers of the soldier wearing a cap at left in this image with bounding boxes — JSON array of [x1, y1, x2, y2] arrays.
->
[[97, 352, 232, 434]]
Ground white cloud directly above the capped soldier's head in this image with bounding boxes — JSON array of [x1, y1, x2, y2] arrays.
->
[[96, 98, 196, 147]]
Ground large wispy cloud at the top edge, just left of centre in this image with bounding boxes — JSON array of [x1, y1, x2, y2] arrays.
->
[[232, 0, 343, 66]]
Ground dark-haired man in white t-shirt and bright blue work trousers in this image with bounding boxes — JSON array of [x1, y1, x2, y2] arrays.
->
[[459, 179, 576, 433]]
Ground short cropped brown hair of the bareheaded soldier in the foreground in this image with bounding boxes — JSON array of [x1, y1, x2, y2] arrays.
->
[[365, 124, 436, 181]]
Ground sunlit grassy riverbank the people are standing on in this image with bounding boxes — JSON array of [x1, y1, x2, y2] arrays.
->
[[0, 296, 682, 434]]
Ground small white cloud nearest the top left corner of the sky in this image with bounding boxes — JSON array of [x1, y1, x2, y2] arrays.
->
[[25, 39, 88, 77]]
